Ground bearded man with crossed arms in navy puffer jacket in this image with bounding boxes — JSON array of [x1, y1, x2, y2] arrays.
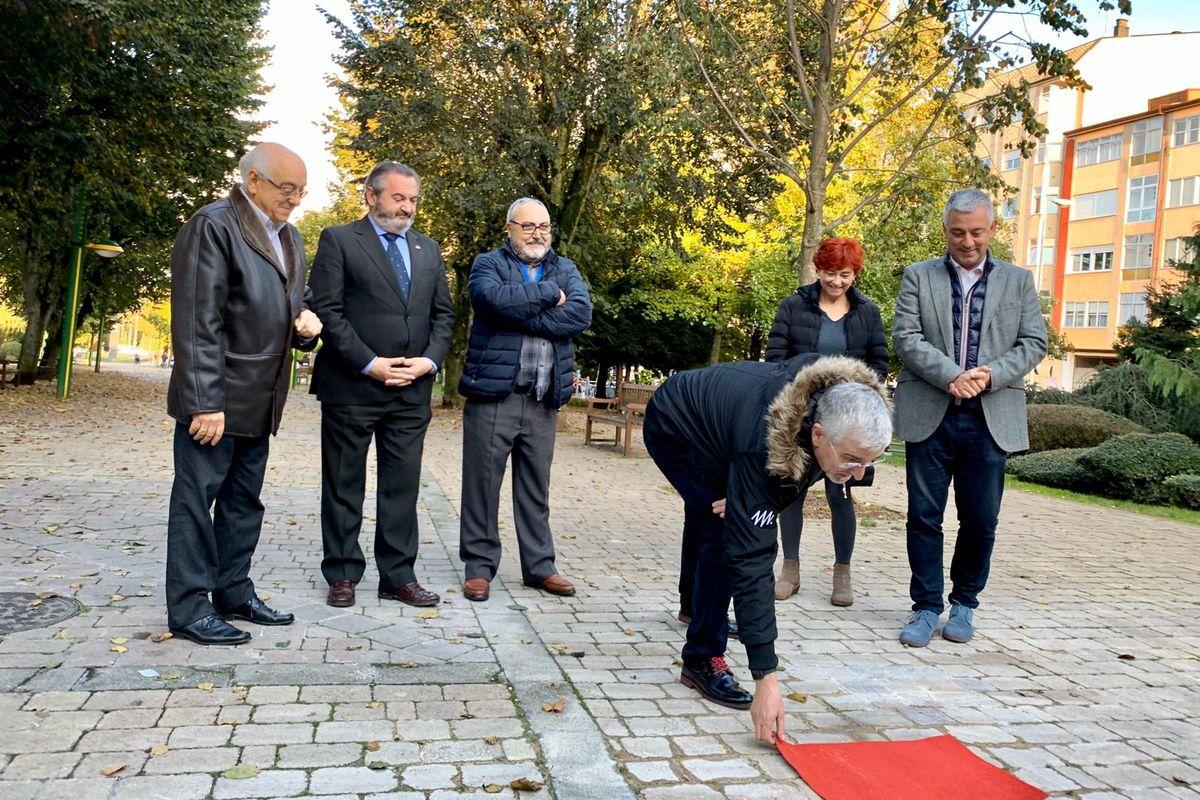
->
[[458, 198, 592, 601]]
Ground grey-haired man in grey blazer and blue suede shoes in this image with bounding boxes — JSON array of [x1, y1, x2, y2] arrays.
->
[[893, 190, 1046, 648]]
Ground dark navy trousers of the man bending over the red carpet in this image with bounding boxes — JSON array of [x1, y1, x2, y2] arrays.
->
[[642, 405, 730, 662]]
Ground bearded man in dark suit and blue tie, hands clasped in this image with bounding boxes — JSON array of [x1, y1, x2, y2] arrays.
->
[[311, 161, 454, 607]]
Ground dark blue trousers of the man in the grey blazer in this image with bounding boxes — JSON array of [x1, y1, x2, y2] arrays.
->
[[905, 405, 1006, 613]]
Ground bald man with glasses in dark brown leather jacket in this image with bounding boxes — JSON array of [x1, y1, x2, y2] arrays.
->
[[167, 143, 320, 644]]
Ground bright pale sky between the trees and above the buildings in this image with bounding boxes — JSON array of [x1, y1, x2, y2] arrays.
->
[[259, 0, 1200, 211]]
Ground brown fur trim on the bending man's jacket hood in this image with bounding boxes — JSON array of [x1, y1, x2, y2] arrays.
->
[[767, 355, 892, 486]]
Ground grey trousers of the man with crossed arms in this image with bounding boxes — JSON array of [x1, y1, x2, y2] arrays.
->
[[458, 395, 558, 582]]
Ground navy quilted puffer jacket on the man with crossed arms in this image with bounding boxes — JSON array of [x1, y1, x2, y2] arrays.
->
[[458, 239, 592, 408]]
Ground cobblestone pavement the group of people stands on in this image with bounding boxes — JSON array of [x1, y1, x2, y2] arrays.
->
[[0, 367, 1200, 800]]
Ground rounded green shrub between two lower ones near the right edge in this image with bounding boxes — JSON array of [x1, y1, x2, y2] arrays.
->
[[1079, 433, 1200, 500]]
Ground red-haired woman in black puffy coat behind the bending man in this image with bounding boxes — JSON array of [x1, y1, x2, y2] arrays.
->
[[767, 239, 888, 606]]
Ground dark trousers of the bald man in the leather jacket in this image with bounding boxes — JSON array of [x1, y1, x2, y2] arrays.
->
[[167, 423, 270, 627]]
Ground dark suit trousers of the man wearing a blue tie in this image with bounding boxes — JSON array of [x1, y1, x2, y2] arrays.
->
[[320, 397, 431, 591]]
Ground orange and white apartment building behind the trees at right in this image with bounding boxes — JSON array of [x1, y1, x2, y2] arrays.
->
[[967, 19, 1200, 389]]
